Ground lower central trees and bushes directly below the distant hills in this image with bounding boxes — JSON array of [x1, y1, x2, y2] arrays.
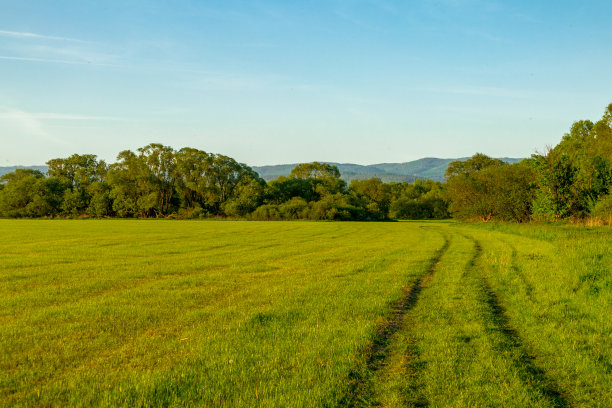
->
[[252, 168, 448, 221]]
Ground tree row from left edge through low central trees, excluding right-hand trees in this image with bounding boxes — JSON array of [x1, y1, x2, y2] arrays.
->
[[0, 144, 448, 220]]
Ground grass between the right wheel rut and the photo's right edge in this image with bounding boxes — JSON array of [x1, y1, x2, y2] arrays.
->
[[464, 224, 612, 407]]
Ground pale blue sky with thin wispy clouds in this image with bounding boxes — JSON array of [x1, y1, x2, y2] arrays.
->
[[0, 0, 612, 166]]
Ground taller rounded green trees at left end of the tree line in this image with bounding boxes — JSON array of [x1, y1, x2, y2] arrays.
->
[[0, 143, 265, 218]]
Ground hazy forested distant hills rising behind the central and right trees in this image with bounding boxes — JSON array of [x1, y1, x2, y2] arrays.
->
[[252, 157, 523, 183]]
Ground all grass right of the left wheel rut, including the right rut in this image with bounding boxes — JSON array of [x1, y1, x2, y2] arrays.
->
[[362, 224, 612, 407]]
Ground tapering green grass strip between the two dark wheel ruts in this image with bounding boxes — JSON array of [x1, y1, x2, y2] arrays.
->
[[377, 234, 546, 407]]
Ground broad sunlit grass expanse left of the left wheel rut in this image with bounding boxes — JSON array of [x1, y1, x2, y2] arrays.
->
[[0, 220, 443, 406]]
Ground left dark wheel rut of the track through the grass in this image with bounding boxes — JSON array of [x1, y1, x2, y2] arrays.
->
[[337, 234, 450, 407]]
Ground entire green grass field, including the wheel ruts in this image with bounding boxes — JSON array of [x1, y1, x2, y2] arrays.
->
[[0, 220, 612, 407]]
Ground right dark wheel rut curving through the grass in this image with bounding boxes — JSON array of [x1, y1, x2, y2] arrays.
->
[[461, 234, 571, 408]]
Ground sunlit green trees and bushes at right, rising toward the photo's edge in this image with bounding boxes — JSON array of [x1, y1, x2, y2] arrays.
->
[[445, 104, 612, 222]]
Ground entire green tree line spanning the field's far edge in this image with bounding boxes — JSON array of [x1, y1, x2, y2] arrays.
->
[[0, 104, 612, 222]]
